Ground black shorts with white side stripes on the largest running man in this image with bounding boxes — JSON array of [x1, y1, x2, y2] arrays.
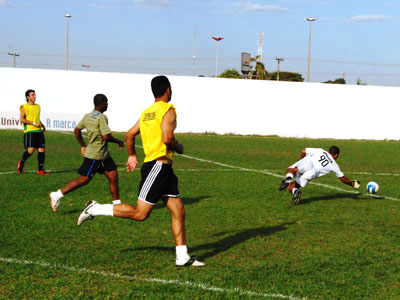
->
[[138, 160, 180, 205]]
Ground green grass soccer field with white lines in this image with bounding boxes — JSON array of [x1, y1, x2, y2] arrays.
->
[[0, 130, 400, 300]]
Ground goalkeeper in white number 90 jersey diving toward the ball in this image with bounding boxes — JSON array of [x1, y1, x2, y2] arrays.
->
[[279, 146, 360, 205]]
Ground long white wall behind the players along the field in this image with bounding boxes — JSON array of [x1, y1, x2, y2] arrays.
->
[[0, 68, 400, 139]]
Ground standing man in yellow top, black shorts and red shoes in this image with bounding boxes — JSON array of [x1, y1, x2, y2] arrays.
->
[[17, 90, 49, 175]]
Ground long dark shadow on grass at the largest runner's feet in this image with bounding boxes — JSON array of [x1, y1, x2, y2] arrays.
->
[[122, 222, 294, 260]]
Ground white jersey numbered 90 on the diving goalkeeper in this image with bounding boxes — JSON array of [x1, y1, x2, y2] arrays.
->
[[305, 148, 344, 178]]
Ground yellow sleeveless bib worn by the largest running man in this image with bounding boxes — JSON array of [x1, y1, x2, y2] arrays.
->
[[140, 101, 176, 162]]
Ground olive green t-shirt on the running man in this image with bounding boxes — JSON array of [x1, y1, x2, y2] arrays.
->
[[76, 110, 111, 160]]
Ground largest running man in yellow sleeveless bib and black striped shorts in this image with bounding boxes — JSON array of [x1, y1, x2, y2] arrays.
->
[[77, 76, 205, 267]]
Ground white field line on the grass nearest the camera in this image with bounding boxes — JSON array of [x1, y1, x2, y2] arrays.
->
[[0, 257, 309, 300]]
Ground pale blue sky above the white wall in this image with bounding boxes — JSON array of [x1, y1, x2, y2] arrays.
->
[[0, 0, 400, 86]]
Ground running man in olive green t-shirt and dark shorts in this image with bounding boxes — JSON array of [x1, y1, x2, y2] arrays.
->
[[49, 94, 124, 212]]
